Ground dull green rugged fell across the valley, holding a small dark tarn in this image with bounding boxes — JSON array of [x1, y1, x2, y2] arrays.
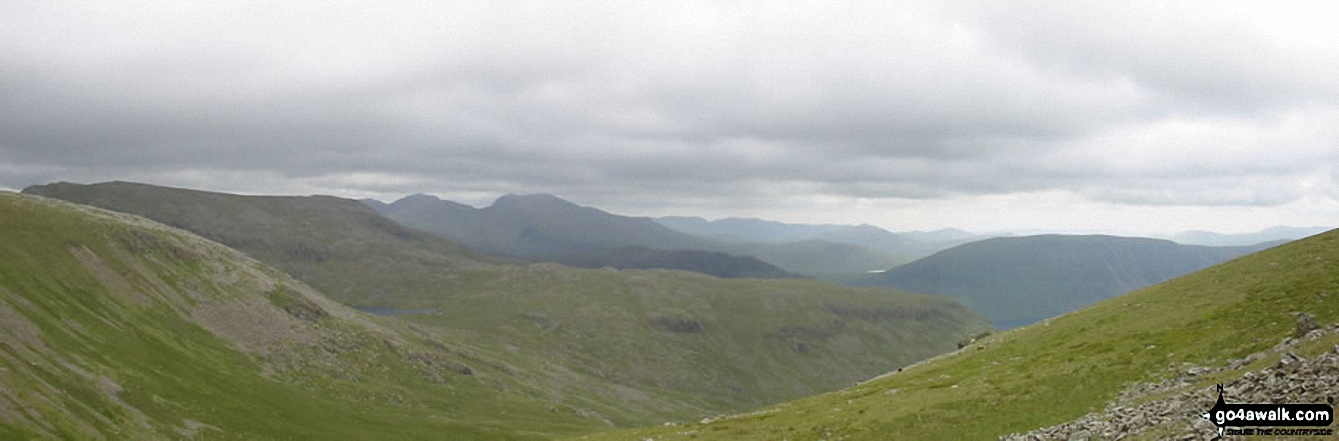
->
[[25, 182, 987, 425]]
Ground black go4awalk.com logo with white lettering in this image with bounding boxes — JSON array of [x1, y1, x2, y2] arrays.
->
[[1200, 385, 1334, 440]]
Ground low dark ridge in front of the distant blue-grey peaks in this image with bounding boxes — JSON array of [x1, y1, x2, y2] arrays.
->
[[553, 247, 799, 279]]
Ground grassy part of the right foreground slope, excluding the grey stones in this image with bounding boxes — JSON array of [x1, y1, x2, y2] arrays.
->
[[594, 227, 1339, 440]]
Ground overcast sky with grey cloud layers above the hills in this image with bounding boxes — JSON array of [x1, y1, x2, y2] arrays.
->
[[0, 0, 1339, 233]]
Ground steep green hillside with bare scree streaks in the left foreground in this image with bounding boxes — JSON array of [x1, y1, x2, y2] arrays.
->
[[0, 192, 600, 440]]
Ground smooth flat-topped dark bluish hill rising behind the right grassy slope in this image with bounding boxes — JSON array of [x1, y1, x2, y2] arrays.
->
[[866, 235, 1275, 328]]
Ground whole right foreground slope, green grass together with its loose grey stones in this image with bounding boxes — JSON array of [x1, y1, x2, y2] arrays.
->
[[594, 225, 1339, 441]]
